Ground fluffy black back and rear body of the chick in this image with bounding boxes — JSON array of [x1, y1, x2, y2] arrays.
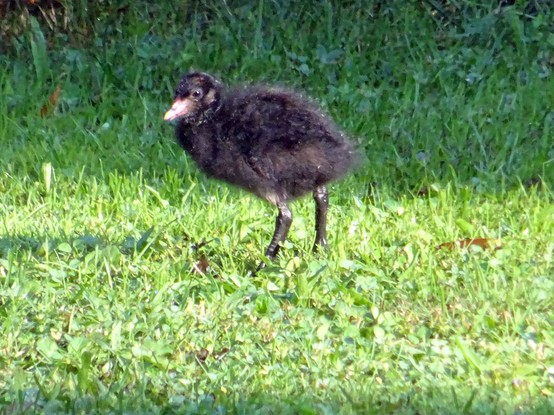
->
[[218, 87, 355, 199]]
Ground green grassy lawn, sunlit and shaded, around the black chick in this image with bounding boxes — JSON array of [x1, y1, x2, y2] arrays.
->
[[0, 1, 554, 414]]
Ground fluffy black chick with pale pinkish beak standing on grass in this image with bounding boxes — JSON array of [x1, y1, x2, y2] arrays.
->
[[164, 71, 359, 271]]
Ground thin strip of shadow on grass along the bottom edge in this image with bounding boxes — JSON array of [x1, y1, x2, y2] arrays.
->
[[0, 388, 554, 415]]
